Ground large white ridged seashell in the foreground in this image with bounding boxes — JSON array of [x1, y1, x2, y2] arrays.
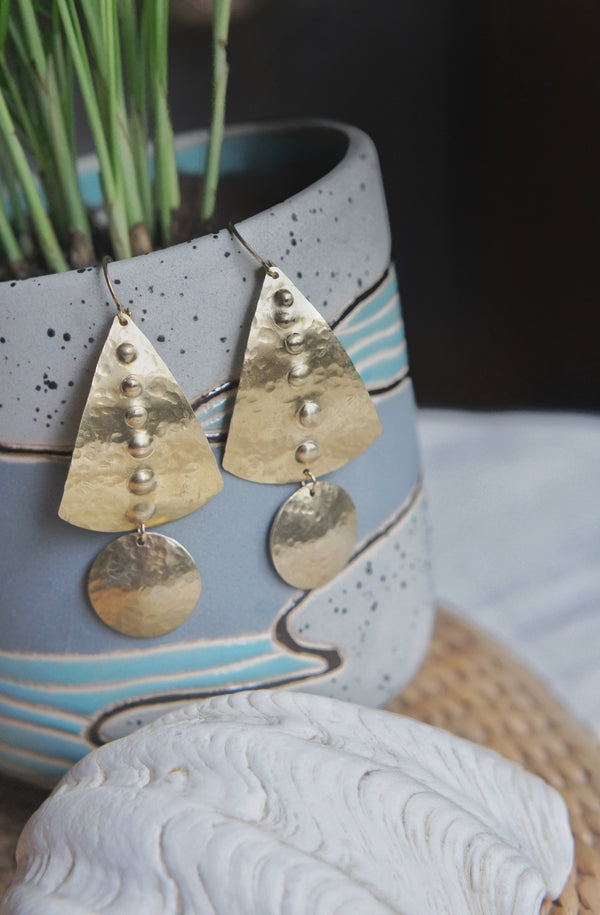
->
[[2, 690, 573, 915]]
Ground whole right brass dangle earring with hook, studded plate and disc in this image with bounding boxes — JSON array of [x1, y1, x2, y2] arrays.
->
[[223, 223, 382, 590]]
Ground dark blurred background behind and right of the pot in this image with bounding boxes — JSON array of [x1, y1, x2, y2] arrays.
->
[[165, 0, 600, 410]]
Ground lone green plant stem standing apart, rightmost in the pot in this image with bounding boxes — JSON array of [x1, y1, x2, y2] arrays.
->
[[201, 0, 231, 220]]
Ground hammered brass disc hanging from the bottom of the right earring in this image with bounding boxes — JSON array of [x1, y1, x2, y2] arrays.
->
[[269, 482, 358, 590]]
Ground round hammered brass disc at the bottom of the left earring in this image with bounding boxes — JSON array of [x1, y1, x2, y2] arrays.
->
[[88, 532, 201, 638]]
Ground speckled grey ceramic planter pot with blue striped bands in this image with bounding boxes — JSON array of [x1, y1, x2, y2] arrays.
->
[[0, 122, 434, 783]]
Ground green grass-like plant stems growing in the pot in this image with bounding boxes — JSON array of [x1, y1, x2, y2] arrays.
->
[[0, 0, 231, 276]]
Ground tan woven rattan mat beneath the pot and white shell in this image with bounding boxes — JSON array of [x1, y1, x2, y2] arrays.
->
[[0, 610, 600, 915]]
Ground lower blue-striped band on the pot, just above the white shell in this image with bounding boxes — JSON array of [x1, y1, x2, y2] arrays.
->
[[0, 635, 324, 780]]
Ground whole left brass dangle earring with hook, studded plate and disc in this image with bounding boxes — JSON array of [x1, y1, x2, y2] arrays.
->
[[58, 257, 223, 638]]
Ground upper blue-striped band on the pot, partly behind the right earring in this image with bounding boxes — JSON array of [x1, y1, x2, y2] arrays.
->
[[196, 267, 408, 438]]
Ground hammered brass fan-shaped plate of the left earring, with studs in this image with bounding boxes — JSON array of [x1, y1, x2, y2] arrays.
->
[[58, 316, 223, 531]]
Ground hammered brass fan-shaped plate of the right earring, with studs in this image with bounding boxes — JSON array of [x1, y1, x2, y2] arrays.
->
[[223, 267, 381, 483]]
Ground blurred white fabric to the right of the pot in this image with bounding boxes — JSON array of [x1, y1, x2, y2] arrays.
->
[[419, 409, 600, 734]]
